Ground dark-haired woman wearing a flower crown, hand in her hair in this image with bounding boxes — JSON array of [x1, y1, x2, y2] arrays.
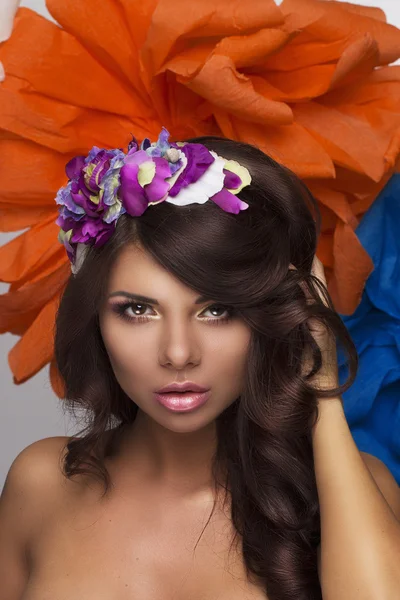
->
[[0, 130, 400, 600]]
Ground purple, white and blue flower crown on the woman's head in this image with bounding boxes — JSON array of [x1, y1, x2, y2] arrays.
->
[[56, 127, 251, 274]]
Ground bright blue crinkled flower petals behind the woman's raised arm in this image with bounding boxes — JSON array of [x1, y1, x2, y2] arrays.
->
[[338, 174, 400, 485]]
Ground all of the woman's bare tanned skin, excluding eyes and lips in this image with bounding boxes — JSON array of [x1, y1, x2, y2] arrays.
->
[[0, 248, 400, 600]]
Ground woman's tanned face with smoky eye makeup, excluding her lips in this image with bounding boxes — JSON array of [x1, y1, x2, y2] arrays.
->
[[100, 246, 251, 432]]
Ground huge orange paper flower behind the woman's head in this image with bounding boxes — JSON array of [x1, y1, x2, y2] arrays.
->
[[0, 0, 400, 395]]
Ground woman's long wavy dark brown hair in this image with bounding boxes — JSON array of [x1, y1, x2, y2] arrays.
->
[[55, 137, 358, 600]]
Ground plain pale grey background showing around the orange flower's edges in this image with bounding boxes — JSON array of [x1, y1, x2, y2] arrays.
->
[[0, 0, 400, 489]]
